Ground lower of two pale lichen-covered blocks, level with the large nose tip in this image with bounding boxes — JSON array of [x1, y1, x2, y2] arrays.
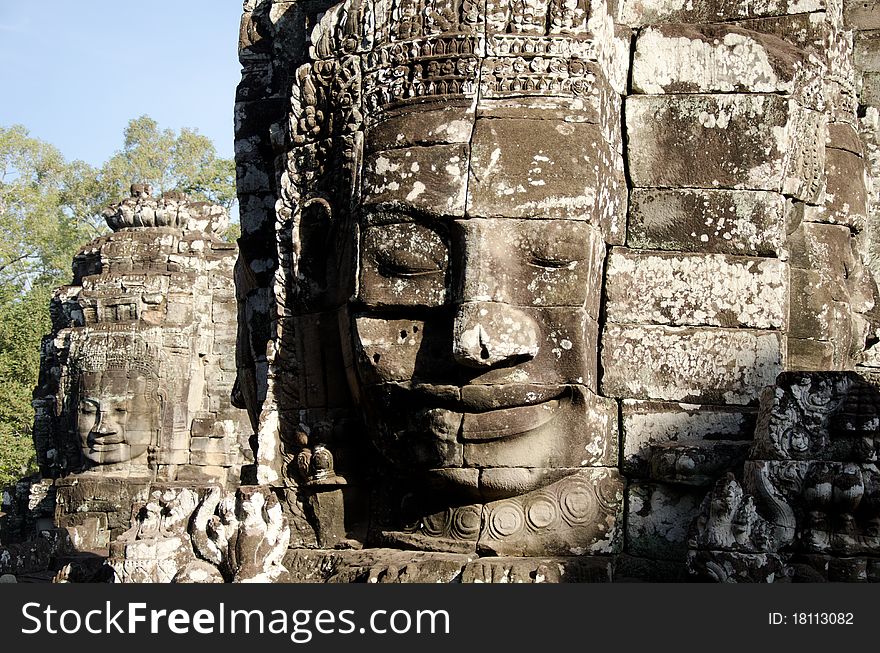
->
[[600, 324, 785, 405]]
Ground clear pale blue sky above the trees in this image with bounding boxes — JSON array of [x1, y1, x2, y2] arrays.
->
[[0, 0, 242, 165]]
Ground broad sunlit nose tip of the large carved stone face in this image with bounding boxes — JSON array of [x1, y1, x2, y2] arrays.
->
[[452, 302, 541, 367]]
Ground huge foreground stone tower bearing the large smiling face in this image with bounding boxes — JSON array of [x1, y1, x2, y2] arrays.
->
[[222, 0, 880, 580]]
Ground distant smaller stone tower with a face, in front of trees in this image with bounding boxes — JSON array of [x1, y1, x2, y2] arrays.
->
[[0, 184, 253, 571]]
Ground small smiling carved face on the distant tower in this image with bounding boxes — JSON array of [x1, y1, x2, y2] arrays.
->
[[76, 369, 161, 465]]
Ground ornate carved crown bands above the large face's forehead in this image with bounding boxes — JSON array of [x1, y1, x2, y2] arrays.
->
[[311, 0, 613, 115]]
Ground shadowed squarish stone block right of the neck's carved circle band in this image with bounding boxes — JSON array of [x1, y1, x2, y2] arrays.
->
[[626, 483, 703, 560]]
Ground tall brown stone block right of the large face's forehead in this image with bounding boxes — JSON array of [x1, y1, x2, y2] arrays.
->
[[626, 94, 825, 198]]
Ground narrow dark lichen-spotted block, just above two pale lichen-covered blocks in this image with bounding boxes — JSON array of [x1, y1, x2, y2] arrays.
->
[[627, 188, 788, 256]]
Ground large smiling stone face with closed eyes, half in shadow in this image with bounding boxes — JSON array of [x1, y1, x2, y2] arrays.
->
[[350, 110, 615, 501]]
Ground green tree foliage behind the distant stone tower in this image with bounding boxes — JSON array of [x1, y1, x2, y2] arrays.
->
[[0, 116, 237, 488]]
